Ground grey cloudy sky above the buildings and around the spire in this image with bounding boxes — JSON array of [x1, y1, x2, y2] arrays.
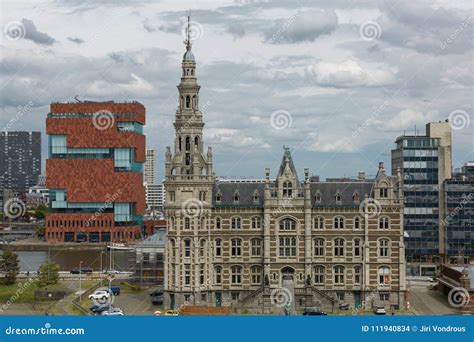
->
[[0, 0, 474, 182]]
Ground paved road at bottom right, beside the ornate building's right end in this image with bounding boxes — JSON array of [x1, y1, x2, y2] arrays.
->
[[408, 282, 459, 315]]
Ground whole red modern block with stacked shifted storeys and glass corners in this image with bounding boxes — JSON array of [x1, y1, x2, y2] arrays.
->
[[45, 101, 145, 242]]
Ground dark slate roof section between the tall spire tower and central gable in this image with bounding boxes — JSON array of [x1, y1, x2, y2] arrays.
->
[[212, 181, 265, 207]]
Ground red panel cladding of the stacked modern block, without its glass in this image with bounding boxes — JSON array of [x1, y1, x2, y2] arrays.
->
[[46, 102, 146, 242]]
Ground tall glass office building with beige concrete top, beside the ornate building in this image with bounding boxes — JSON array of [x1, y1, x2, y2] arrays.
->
[[392, 122, 451, 276]]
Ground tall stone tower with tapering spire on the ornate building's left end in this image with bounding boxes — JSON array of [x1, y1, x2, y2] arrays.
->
[[164, 17, 214, 307]]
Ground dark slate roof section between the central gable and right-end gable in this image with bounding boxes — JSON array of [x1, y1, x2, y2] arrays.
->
[[310, 182, 374, 206]]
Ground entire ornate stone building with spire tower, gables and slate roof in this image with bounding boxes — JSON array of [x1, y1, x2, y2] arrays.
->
[[164, 33, 405, 311]]
